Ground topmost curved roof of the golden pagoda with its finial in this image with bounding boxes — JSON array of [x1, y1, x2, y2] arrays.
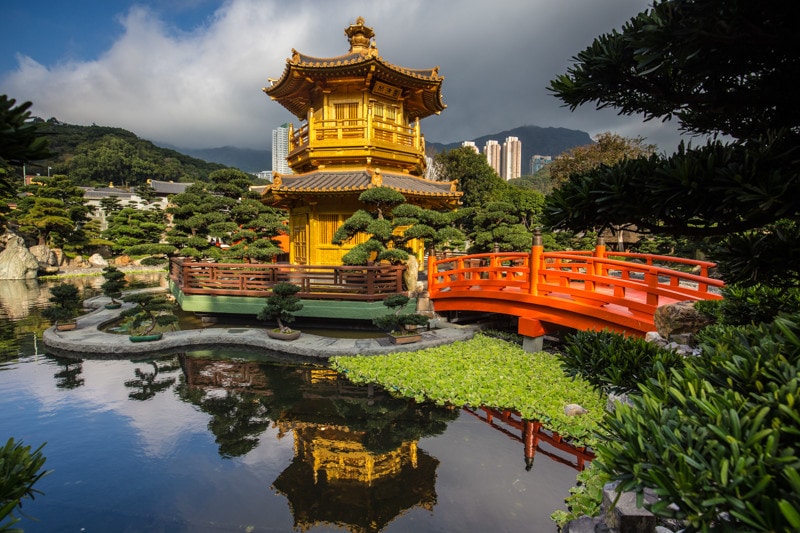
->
[[263, 17, 447, 120]]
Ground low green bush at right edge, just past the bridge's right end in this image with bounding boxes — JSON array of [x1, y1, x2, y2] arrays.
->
[[695, 285, 800, 326]]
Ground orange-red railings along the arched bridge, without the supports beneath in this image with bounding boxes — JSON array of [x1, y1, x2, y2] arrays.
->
[[428, 245, 724, 316]]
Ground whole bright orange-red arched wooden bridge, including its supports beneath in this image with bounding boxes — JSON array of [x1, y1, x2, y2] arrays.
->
[[428, 242, 724, 338]]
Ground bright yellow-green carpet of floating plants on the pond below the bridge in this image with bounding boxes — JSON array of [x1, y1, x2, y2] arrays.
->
[[330, 335, 606, 446]]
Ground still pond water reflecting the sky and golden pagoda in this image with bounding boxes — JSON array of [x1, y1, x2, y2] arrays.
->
[[0, 278, 577, 532]]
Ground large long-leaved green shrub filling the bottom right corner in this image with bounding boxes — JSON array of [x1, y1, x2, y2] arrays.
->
[[595, 314, 800, 531]]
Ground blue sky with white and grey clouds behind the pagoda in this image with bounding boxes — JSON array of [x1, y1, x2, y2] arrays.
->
[[0, 0, 679, 151]]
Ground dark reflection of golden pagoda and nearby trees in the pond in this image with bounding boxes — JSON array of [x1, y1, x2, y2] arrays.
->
[[181, 356, 446, 532]]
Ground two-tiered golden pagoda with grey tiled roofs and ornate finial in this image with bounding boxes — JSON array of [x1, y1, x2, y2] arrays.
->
[[262, 17, 461, 265]]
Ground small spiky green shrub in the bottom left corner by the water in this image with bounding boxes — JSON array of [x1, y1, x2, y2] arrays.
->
[[0, 437, 50, 531]]
